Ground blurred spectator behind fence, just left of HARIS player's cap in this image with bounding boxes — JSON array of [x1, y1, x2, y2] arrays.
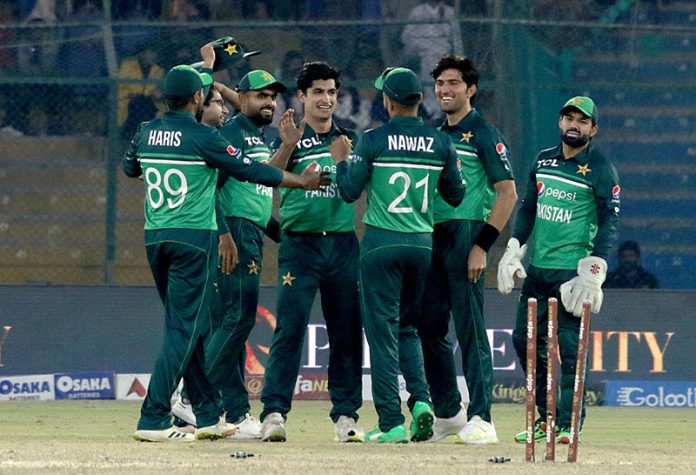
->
[[118, 44, 164, 138]]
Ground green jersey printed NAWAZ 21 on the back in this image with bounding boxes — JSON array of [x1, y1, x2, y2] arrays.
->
[[336, 117, 464, 233]]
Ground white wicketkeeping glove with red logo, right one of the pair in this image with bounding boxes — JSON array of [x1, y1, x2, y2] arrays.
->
[[561, 256, 607, 317]]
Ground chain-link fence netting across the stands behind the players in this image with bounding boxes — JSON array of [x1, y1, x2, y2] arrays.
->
[[0, 1, 696, 288]]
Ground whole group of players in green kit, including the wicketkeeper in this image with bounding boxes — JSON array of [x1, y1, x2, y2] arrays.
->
[[123, 39, 620, 444]]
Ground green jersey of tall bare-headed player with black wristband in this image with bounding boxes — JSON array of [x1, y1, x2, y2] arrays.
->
[[435, 109, 513, 223]]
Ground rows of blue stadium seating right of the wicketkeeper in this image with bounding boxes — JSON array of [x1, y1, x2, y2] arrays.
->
[[573, 1, 696, 288]]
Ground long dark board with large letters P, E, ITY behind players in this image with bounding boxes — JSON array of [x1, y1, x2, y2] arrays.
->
[[0, 286, 696, 386]]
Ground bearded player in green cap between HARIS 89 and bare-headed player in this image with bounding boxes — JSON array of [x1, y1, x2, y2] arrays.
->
[[206, 70, 302, 439]]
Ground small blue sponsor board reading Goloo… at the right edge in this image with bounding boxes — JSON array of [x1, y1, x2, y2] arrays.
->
[[604, 380, 696, 407]]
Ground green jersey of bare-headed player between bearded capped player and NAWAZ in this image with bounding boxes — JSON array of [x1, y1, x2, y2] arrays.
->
[[273, 123, 357, 233]]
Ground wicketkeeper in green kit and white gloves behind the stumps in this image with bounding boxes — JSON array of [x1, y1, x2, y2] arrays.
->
[[498, 96, 621, 444]]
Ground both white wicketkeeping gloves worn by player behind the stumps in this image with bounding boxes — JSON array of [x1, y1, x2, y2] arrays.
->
[[498, 238, 607, 317]]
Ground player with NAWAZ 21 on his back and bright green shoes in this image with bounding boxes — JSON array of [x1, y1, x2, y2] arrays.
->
[[331, 68, 464, 443]]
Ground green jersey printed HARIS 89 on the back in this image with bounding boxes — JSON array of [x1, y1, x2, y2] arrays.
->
[[123, 111, 283, 230]]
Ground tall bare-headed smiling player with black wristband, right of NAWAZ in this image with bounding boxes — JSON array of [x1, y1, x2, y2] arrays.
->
[[420, 55, 517, 444]]
